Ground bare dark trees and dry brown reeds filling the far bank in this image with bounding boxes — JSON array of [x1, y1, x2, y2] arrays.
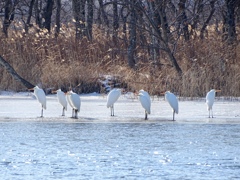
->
[[0, 0, 240, 96]]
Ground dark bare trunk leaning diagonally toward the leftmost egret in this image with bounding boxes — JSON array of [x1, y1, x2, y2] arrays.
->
[[0, 55, 34, 89]]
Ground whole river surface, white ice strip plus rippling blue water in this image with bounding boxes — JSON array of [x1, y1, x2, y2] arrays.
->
[[0, 94, 240, 179]]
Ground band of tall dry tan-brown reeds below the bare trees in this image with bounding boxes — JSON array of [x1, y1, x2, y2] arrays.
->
[[0, 22, 240, 97]]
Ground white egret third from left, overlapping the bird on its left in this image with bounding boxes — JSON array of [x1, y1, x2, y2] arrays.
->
[[66, 91, 81, 119]]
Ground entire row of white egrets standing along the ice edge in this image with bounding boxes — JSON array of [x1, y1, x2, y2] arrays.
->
[[30, 86, 220, 121]]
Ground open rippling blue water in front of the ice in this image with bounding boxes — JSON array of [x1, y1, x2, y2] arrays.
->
[[0, 122, 240, 179]]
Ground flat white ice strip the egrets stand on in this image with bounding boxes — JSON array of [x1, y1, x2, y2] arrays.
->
[[0, 91, 240, 123]]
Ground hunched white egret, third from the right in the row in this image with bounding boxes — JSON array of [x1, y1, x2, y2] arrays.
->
[[138, 90, 151, 120]]
